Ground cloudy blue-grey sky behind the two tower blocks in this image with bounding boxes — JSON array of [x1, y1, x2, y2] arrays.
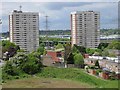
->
[[0, 0, 118, 32]]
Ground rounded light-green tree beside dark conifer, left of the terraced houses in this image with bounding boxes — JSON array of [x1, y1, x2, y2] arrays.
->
[[74, 53, 84, 67]]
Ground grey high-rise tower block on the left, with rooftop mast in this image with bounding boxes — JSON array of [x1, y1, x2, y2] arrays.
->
[[9, 10, 39, 52]]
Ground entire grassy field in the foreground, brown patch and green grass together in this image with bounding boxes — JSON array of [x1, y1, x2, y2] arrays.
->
[[3, 67, 118, 88]]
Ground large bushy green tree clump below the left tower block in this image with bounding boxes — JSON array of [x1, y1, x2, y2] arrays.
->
[[3, 52, 42, 78]]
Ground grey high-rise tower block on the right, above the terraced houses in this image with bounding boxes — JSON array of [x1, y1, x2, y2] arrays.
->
[[71, 11, 100, 48]]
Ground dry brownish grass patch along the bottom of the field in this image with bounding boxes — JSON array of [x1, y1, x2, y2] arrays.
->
[[2, 77, 92, 88]]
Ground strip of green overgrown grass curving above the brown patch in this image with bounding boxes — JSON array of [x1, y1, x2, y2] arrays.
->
[[37, 67, 118, 88]]
